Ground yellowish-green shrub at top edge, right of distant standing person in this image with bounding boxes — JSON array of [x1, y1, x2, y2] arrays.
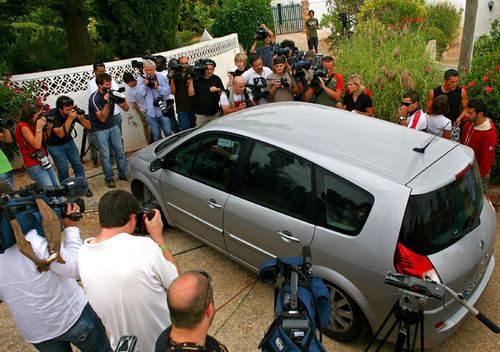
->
[[357, 0, 427, 30]]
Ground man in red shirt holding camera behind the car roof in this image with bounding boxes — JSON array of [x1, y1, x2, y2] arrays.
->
[[304, 56, 344, 107]]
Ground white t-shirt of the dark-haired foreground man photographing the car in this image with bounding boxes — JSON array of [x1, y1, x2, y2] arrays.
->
[[78, 233, 178, 352]]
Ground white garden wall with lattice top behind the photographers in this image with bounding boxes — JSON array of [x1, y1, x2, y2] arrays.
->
[[11, 34, 240, 167]]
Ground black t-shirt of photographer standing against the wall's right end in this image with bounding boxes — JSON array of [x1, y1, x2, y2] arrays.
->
[[193, 75, 224, 115]]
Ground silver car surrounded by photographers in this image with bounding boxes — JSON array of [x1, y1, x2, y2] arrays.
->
[[129, 103, 496, 347]]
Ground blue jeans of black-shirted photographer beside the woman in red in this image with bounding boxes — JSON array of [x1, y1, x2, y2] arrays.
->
[[47, 140, 85, 182]]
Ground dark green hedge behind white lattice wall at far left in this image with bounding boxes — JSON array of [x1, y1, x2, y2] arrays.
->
[[0, 23, 68, 73]]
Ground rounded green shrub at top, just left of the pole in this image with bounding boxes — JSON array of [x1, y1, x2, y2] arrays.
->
[[427, 2, 460, 40]]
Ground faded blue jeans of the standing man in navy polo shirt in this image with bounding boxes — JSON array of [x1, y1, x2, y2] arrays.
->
[[93, 125, 127, 182]]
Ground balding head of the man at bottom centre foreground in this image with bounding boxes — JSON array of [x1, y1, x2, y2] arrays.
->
[[167, 271, 213, 329]]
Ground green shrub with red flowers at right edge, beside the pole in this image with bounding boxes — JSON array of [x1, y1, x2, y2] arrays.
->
[[461, 20, 500, 184]]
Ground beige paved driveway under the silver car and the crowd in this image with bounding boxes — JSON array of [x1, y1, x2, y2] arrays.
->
[[0, 168, 500, 352]]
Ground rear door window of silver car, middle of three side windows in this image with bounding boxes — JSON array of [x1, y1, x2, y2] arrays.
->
[[240, 142, 314, 221]]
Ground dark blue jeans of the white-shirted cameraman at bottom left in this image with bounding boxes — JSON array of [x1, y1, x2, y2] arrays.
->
[[33, 303, 112, 352]]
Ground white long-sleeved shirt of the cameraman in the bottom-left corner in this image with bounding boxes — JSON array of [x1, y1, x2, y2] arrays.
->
[[0, 227, 87, 343]]
